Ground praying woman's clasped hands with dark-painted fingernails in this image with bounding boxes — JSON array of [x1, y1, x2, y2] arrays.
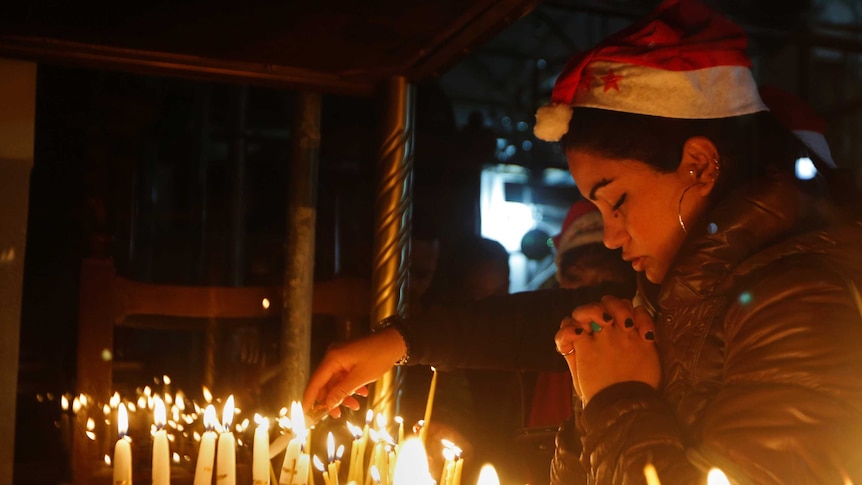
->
[[555, 296, 661, 404]]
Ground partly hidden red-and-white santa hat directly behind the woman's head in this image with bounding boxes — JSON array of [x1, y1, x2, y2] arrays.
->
[[760, 85, 836, 168]]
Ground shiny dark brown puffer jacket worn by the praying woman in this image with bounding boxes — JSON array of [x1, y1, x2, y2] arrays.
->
[[556, 172, 862, 484]]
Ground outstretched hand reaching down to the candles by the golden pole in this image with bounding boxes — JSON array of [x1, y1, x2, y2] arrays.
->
[[302, 328, 407, 418]]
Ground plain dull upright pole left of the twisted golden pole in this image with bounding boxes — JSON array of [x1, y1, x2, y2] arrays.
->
[[281, 92, 320, 403]]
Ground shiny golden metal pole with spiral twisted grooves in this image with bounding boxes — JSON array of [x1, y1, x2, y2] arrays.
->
[[370, 76, 415, 417]]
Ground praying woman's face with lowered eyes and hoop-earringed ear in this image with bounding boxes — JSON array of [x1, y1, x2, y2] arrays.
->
[[566, 150, 698, 283]]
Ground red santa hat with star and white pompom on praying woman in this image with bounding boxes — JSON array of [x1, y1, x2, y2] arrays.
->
[[534, 0, 766, 141]]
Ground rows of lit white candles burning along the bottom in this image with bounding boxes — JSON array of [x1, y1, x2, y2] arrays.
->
[[50, 372, 729, 485]]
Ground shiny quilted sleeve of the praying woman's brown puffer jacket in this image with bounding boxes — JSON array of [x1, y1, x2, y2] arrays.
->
[[581, 258, 862, 484]]
